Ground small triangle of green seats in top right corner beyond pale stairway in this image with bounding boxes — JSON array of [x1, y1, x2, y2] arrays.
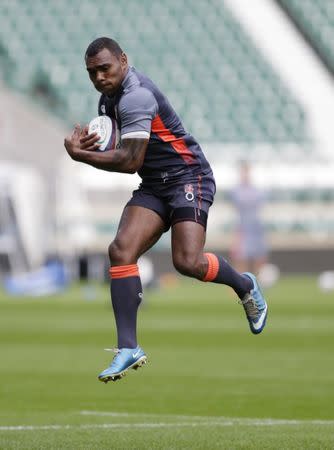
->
[[277, 0, 334, 74]]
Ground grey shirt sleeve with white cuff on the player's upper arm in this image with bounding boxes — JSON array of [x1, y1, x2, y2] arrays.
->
[[118, 87, 158, 139]]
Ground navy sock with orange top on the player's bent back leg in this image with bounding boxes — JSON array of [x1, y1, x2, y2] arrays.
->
[[203, 253, 253, 299]]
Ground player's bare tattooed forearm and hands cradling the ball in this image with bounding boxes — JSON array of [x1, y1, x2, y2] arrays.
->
[[64, 125, 148, 173]]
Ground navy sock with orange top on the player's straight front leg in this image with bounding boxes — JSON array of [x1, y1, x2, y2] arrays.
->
[[110, 264, 142, 348]]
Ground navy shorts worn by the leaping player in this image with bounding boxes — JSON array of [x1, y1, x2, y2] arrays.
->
[[126, 173, 216, 231]]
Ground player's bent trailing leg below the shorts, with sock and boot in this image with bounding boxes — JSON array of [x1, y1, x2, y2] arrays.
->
[[172, 220, 267, 334]]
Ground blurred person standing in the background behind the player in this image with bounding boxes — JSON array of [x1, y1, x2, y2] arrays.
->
[[229, 161, 268, 275]]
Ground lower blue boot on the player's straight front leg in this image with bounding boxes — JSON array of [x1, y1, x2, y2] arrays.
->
[[98, 346, 147, 383]]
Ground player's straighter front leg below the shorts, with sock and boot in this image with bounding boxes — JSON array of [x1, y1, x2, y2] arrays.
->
[[99, 206, 165, 382]]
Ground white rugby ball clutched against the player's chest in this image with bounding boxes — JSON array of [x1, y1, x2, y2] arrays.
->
[[88, 116, 120, 152]]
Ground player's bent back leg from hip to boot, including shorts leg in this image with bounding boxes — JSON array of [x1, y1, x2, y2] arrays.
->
[[169, 173, 267, 334]]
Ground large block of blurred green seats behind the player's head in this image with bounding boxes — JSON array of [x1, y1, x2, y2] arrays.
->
[[0, 0, 311, 144]]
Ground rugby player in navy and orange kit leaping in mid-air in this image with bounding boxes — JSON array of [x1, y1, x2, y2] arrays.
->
[[65, 37, 267, 382]]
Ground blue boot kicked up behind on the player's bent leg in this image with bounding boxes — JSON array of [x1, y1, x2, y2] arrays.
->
[[240, 272, 268, 334]]
